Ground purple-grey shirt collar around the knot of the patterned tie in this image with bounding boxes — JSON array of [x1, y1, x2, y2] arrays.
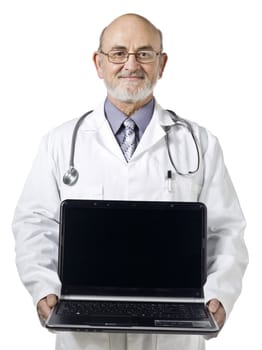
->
[[104, 98, 155, 135]]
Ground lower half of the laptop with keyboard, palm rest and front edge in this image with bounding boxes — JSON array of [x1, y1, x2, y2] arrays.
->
[[46, 300, 218, 335]]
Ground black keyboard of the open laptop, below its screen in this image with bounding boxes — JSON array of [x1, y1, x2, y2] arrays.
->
[[57, 301, 208, 320]]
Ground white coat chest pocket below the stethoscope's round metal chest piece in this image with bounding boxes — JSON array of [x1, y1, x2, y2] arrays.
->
[[61, 184, 104, 200]]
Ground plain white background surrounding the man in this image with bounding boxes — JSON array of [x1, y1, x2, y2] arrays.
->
[[0, 0, 262, 350]]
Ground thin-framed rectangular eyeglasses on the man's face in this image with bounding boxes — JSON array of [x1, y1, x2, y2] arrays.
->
[[99, 50, 161, 64]]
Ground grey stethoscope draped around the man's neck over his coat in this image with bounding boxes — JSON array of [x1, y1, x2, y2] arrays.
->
[[63, 110, 200, 187]]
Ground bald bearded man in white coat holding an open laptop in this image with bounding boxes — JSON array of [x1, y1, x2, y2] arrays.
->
[[13, 14, 248, 350]]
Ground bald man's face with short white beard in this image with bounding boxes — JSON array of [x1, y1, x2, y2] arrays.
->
[[94, 17, 166, 103]]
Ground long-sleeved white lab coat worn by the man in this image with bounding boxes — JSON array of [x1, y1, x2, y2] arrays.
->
[[13, 103, 248, 350]]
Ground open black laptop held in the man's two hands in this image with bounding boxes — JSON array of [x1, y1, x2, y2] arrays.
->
[[46, 199, 218, 334]]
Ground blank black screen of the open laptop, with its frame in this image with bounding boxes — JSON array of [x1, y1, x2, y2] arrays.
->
[[59, 200, 206, 295]]
